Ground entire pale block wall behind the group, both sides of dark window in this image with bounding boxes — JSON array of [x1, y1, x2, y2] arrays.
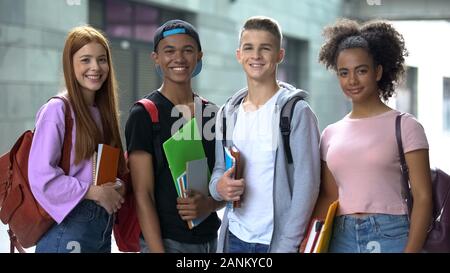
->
[[0, 0, 347, 153]]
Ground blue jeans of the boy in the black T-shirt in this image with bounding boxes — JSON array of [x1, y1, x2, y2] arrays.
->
[[139, 234, 217, 253]]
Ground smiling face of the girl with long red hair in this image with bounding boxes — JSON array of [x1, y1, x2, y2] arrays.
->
[[73, 42, 109, 96]]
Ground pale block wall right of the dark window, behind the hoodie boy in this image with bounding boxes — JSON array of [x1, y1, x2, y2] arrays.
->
[[141, 0, 348, 128]]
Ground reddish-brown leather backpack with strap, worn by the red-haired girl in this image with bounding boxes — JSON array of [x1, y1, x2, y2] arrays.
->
[[0, 96, 73, 252]]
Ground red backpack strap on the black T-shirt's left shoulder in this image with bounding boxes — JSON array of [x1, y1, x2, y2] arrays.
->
[[136, 99, 164, 174]]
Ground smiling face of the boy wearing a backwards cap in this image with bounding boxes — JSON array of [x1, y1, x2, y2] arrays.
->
[[152, 34, 203, 83]]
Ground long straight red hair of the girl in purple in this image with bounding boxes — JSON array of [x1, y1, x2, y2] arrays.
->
[[62, 26, 125, 173]]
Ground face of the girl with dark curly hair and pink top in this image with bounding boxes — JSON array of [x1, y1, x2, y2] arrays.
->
[[336, 48, 382, 103]]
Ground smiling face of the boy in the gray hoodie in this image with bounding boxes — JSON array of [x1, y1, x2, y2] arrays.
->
[[236, 30, 284, 81]]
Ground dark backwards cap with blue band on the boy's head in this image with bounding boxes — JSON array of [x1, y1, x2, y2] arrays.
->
[[153, 19, 202, 52]]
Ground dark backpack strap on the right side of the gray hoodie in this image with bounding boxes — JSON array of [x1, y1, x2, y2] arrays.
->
[[280, 95, 303, 164]]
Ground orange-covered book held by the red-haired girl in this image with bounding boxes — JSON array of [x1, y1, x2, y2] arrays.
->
[[94, 144, 120, 185]]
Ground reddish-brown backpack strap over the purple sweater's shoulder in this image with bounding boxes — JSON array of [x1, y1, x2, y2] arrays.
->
[[52, 96, 73, 174]]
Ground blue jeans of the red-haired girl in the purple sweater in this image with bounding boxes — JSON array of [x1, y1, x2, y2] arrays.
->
[[36, 200, 114, 253]]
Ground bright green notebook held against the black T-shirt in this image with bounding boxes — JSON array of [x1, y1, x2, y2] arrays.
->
[[163, 118, 206, 196]]
